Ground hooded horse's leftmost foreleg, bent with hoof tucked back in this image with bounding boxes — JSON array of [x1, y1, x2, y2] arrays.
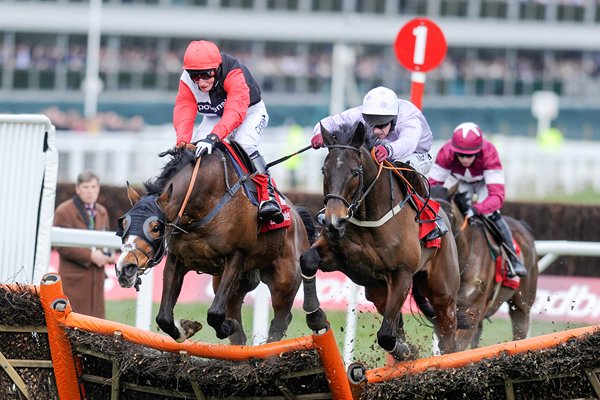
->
[[156, 255, 202, 342]]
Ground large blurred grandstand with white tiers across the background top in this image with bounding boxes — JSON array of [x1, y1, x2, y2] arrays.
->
[[0, 0, 600, 139]]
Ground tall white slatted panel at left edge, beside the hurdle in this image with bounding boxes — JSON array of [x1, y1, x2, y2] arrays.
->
[[0, 115, 58, 284]]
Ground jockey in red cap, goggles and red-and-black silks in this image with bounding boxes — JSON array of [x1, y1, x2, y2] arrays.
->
[[173, 40, 284, 223]]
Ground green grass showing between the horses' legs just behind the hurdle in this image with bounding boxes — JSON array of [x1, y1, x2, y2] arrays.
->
[[106, 301, 583, 368]]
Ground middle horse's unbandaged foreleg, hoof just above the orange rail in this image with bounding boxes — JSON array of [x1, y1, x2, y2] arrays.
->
[[377, 268, 418, 360]]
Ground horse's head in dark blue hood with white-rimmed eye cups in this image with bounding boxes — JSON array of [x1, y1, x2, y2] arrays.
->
[[115, 184, 165, 289]]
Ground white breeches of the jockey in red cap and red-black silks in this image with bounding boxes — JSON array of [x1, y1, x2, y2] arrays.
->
[[192, 100, 269, 155]]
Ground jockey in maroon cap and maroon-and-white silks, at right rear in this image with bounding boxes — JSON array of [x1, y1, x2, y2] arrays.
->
[[429, 122, 527, 277]]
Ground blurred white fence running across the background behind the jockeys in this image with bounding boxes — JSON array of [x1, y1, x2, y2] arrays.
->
[[57, 127, 600, 199]]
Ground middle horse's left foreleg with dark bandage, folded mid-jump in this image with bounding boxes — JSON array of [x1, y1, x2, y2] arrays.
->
[[300, 245, 327, 332]]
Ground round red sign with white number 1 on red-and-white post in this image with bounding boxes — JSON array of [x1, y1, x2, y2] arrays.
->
[[394, 18, 448, 108]]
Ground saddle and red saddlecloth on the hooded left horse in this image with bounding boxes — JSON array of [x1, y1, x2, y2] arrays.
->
[[218, 140, 292, 233]]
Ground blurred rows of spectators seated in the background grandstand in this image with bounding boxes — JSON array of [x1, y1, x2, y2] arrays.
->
[[0, 43, 600, 96]]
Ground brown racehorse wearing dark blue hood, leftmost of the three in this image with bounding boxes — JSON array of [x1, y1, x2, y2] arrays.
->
[[115, 145, 315, 344]]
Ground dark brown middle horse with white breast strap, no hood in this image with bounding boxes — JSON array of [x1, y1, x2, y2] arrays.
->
[[300, 123, 460, 360]]
